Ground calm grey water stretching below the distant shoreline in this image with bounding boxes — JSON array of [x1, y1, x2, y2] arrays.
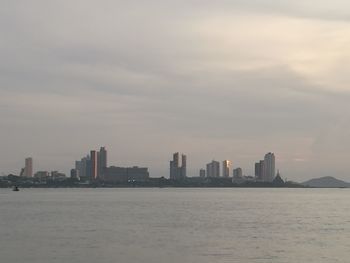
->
[[0, 188, 350, 263]]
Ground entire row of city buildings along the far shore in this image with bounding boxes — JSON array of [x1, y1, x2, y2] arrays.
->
[[15, 151, 280, 186]]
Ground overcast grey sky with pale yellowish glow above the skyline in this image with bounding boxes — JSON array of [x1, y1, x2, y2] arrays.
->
[[0, 0, 350, 181]]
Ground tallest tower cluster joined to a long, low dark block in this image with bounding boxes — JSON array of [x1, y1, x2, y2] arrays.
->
[[71, 147, 149, 183]]
